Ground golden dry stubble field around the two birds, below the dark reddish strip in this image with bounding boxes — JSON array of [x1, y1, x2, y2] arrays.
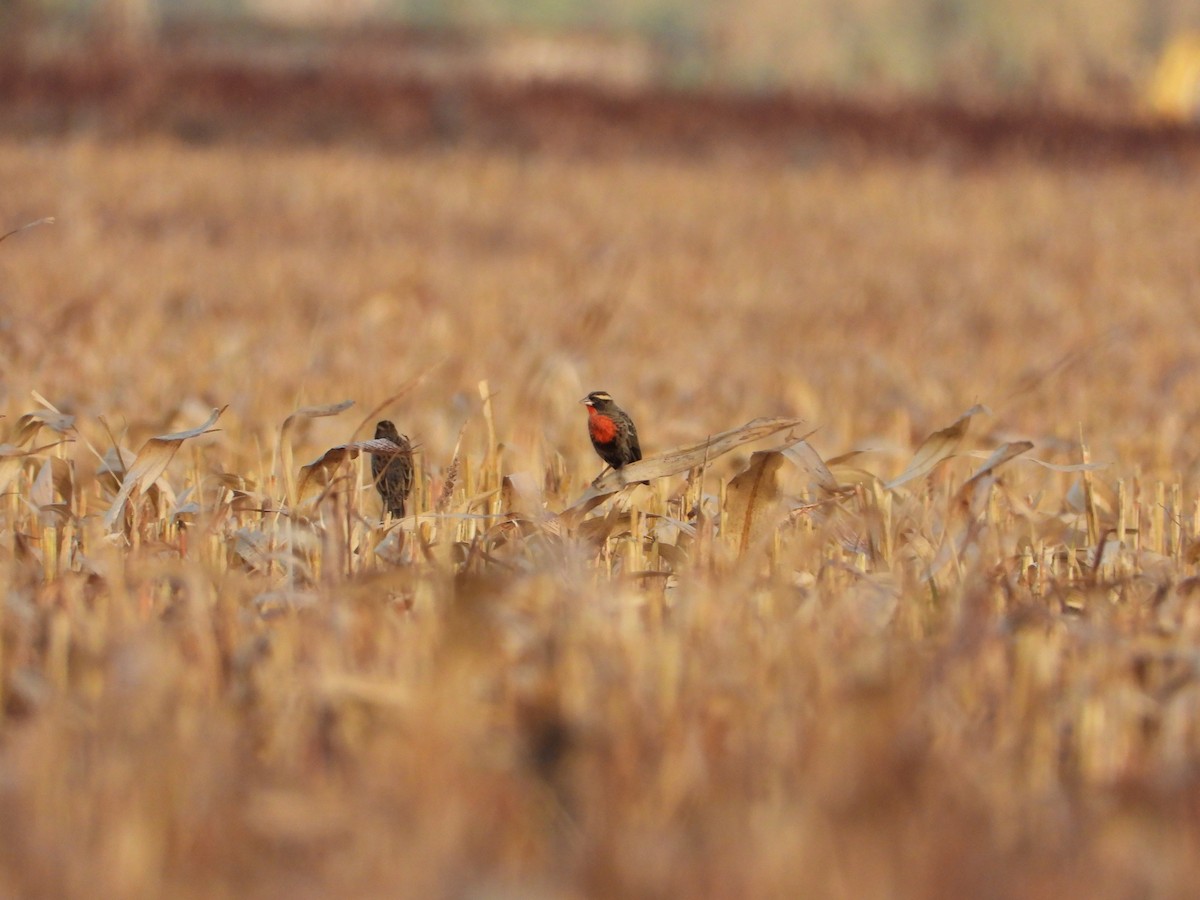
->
[[0, 111, 1200, 899]]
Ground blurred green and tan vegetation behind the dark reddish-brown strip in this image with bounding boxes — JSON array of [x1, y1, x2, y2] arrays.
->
[[0, 0, 1200, 112]]
